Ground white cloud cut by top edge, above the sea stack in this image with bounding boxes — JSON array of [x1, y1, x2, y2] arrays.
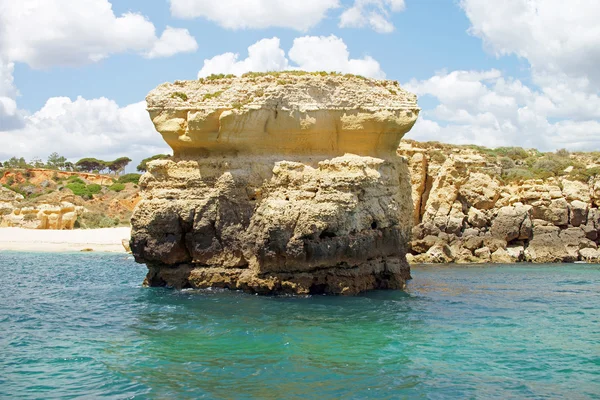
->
[[170, 0, 339, 31]]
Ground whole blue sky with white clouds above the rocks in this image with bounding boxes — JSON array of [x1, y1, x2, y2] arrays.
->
[[0, 0, 600, 166]]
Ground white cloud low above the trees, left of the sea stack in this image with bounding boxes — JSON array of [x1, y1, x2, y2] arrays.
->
[[0, 97, 169, 161]]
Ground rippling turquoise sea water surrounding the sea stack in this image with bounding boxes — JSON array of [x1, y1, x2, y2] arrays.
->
[[0, 252, 600, 399]]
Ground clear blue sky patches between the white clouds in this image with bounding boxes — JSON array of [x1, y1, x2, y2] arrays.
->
[[15, 0, 526, 111]]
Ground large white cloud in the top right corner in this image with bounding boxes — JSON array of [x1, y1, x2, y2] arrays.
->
[[460, 0, 600, 92]]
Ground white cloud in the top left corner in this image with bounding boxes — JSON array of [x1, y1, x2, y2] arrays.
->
[[0, 0, 195, 68]]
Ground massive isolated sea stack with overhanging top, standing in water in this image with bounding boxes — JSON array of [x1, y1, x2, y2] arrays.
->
[[131, 74, 419, 294]]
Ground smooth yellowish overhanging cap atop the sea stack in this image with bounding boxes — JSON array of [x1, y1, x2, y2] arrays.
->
[[146, 71, 420, 156]]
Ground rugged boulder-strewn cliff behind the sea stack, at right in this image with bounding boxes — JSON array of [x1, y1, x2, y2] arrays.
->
[[398, 141, 600, 263]]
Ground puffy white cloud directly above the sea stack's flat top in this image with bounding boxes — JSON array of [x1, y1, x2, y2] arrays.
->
[[198, 35, 385, 78]]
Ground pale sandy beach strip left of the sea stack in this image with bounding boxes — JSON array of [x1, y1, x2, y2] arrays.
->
[[0, 227, 131, 253]]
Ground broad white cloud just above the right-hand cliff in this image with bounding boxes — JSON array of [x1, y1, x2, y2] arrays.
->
[[404, 70, 600, 150]]
